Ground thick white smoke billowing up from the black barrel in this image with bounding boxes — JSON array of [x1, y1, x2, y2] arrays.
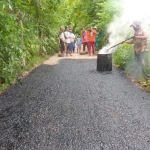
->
[[99, 0, 150, 53]]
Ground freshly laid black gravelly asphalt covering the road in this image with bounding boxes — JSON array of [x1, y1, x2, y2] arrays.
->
[[0, 59, 150, 150]]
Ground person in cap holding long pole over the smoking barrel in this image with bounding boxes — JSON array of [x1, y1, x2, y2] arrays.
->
[[122, 21, 150, 78]]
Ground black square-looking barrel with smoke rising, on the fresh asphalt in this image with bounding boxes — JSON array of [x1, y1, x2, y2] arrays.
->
[[97, 53, 112, 72]]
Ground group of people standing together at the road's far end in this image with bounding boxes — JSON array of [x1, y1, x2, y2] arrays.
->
[[58, 26, 100, 56]]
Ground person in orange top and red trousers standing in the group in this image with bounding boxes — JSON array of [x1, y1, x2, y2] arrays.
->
[[88, 27, 97, 56]]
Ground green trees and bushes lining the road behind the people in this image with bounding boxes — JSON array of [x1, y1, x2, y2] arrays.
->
[[0, 0, 150, 91]]
